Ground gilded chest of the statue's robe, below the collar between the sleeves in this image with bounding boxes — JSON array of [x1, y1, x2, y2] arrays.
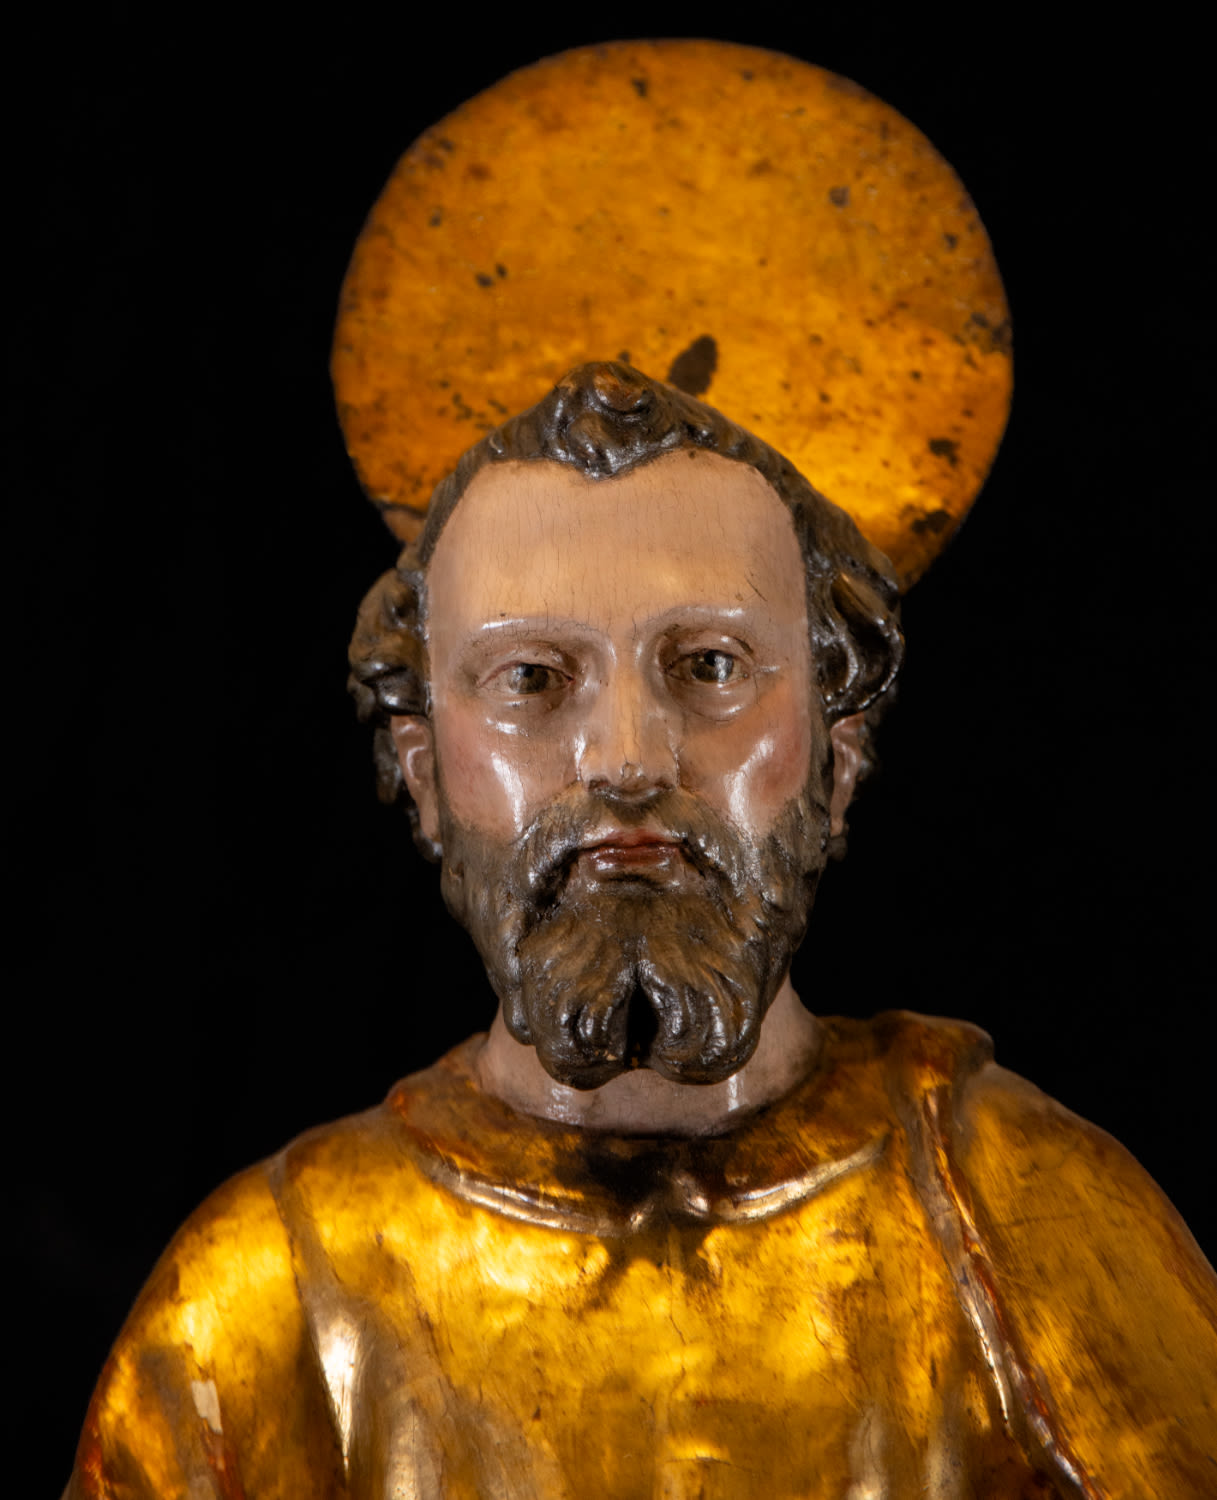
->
[[319, 1173, 1037, 1500]]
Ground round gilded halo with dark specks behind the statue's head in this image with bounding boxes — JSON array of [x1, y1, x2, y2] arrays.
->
[[332, 41, 1011, 587]]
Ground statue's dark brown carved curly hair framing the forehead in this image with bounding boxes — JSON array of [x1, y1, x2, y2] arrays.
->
[[350, 363, 903, 857]]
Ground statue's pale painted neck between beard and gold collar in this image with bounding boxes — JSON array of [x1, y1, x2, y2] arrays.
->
[[476, 977, 819, 1136]]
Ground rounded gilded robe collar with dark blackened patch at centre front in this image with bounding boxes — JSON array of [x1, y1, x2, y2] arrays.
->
[[387, 1013, 987, 1236]]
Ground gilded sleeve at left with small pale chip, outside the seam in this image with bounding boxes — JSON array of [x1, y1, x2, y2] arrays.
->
[[65, 1167, 345, 1500]]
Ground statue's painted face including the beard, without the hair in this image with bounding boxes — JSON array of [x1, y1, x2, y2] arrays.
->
[[399, 452, 830, 1088]]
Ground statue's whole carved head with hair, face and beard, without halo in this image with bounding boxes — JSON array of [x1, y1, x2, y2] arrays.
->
[[351, 365, 900, 1088]]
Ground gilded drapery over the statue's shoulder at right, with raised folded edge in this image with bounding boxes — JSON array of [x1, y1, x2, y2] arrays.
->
[[827, 1011, 1217, 1500]]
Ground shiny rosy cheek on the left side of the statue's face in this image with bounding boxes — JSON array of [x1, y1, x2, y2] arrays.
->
[[434, 701, 572, 840]]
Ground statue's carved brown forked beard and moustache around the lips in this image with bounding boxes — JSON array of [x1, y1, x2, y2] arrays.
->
[[441, 774, 828, 1089]]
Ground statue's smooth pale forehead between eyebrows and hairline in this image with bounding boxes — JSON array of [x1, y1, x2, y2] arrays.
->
[[428, 450, 806, 633]]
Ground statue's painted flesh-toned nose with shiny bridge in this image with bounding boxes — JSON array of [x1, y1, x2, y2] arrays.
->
[[576, 665, 678, 798]]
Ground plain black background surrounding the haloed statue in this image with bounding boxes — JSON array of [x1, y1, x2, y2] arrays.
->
[[5, 6, 1217, 1491]]
